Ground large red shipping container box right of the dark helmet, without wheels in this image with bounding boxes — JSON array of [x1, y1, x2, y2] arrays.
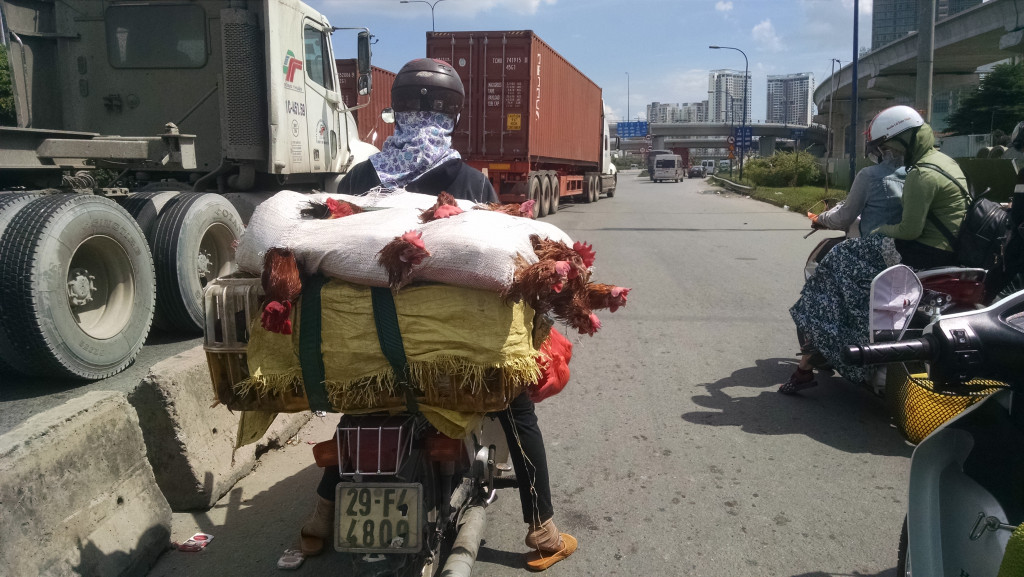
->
[[427, 30, 604, 168]]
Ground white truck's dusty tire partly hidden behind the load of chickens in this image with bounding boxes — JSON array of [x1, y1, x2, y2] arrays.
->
[[153, 193, 244, 334]]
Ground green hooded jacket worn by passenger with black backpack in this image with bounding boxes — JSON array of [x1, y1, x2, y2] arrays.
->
[[876, 124, 967, 251]]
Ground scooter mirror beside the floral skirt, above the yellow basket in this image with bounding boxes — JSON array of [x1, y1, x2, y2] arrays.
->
[[867, 264, 925, 342]]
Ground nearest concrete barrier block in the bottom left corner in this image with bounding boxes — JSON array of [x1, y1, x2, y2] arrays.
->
[[0, 391, 171, 577]]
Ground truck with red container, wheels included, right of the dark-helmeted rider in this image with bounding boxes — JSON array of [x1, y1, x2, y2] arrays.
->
[[427, 30, 616, 217]]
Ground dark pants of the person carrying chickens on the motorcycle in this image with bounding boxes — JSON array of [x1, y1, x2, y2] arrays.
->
[[316, 393, 554, 524]]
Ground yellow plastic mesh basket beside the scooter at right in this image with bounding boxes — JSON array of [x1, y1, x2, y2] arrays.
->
[[886, 364, 1007, 445]]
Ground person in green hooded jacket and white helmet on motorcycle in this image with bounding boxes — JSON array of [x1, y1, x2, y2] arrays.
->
[[867, 106, 967, 270]]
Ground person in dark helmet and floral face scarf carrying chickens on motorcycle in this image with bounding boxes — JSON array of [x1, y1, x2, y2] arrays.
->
[[300, 58, 577, 571]]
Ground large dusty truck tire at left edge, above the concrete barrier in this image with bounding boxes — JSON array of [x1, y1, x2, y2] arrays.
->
[[0, 194, 156, 380]]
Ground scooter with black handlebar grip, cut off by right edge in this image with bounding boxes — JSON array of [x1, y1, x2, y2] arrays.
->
[[843, 291, 1024, 577]]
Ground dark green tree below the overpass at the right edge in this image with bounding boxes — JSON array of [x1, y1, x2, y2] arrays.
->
[[946, 63, 1024, 134]]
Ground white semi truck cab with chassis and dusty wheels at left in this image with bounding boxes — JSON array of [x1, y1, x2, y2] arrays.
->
[[0, 0, 377, 380]]
